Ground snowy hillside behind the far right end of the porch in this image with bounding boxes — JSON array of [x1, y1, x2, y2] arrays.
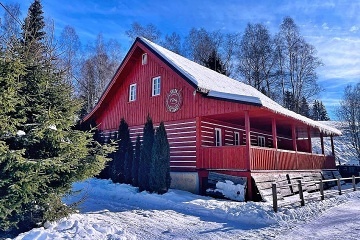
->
[[312, 121, 359, 165]]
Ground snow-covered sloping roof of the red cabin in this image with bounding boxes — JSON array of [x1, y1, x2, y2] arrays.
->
[[139, 38, 341, 135]]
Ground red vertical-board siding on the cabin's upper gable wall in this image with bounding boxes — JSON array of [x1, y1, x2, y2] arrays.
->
[[93, 43, 255, 130]]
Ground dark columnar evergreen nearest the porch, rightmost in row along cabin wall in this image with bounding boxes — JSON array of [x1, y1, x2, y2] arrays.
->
[[150, 122, 171, 194]]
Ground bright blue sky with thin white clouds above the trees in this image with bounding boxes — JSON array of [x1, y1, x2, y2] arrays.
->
[[0, 0, 360, 118]]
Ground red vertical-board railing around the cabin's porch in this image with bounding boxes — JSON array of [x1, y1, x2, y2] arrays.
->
[[198, 145, 336, 170]]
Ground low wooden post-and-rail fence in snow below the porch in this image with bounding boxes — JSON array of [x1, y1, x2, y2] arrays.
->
[[272, 176, 360, 212]]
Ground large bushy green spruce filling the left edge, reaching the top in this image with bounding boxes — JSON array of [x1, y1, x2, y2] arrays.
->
[[0, 0, 112, 234]]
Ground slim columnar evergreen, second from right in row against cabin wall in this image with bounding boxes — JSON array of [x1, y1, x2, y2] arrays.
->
[[138, 115, 154, 191]]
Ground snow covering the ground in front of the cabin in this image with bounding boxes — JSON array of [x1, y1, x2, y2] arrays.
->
[[15, 179, 360, 240]]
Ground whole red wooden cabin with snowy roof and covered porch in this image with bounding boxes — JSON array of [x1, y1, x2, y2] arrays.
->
[[83, 38, 341, 198]]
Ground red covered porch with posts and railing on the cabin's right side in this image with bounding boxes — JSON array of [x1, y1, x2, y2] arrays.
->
[[197, 109, 336, 171]]
